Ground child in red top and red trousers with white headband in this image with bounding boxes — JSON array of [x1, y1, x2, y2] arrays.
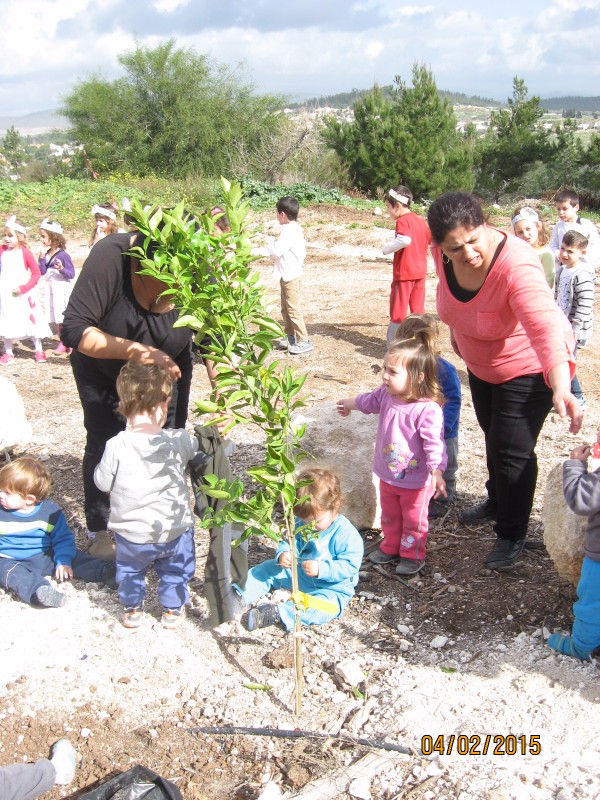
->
[[383, 186, 431, 348]]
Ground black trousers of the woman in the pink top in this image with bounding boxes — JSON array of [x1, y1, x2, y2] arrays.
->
[[469, 372, 552, 540]]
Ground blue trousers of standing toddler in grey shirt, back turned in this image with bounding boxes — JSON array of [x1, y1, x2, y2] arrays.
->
[[115, 528, 196, 608]]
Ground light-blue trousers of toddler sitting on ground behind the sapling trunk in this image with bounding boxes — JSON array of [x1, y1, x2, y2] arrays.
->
[[238, 558, 342, 631]]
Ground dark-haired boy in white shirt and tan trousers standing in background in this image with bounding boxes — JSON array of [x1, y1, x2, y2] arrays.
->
[[268, 197, 313, 356]]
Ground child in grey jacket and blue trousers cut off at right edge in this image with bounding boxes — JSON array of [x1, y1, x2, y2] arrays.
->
[[548, 429, 600, 661]]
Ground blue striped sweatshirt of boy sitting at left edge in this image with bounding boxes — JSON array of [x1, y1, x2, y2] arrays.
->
[[0, 500, 75, 567]]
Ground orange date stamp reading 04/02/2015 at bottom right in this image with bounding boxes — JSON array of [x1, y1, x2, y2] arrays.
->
[[421, 733, 542, 756]]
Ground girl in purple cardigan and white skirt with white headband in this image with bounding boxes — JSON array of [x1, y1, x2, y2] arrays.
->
[[38, 217, 75, 355]]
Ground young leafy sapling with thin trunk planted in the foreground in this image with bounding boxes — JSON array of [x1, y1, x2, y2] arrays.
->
[[127, 179, 332, 714]]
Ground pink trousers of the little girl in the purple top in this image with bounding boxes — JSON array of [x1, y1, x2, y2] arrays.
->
[[379, 481, 432, 561]]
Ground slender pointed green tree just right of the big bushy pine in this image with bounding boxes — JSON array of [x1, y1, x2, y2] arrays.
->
[[475, 77, 553, 202]]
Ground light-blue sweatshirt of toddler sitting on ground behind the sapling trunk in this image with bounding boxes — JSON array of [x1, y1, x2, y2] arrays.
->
[[275, 514, 364, 608]]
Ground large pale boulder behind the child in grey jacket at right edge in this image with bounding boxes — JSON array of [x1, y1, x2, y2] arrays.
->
[[542, 464, 587, 586]]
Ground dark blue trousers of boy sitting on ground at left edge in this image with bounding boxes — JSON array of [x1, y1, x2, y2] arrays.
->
[[0, 550, 109, 605]]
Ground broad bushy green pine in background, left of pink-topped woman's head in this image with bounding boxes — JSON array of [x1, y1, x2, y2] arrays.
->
[[322, 64, 473, 198]]
